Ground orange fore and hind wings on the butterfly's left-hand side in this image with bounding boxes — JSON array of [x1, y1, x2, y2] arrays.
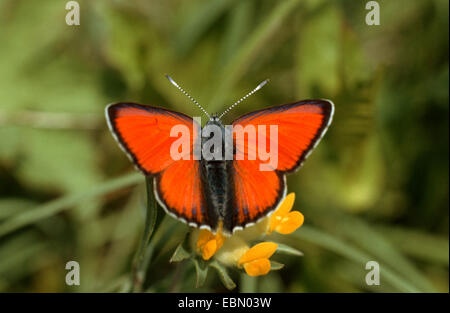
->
[[106, 103, 209, 226]]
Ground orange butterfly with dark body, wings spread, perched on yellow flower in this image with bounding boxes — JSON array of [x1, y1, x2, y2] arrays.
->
[[105, 75, 334, 234]]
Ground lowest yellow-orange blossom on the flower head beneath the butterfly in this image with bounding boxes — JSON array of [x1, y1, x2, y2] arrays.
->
[[238, 242, 278, 276]]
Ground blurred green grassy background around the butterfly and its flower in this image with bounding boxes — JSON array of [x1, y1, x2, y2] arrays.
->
[[0, 0, 449, 292]]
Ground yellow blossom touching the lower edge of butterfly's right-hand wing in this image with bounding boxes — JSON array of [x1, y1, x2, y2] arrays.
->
[[267, 192, 304, 235]]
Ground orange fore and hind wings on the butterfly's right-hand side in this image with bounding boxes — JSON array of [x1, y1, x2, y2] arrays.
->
[[233, 100, 334, 228]]
